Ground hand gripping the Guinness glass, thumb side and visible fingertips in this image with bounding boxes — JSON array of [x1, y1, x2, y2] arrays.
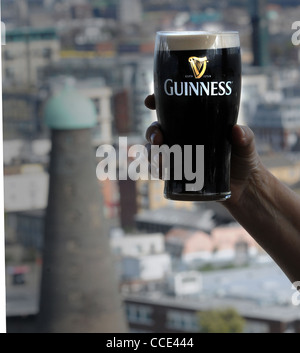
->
[[145, 95, 263, 206]]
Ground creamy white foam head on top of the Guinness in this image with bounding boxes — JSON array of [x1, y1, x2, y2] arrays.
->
[[156, 31, 240, 51]]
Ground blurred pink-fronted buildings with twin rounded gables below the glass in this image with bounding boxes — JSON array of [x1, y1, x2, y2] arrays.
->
[[165, 223, 260, 269]]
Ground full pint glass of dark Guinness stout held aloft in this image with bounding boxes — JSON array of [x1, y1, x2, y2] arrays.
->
[[154, 32, 241, 201]]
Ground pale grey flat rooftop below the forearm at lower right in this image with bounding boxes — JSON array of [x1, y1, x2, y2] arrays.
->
[[124, 262, 300, 322]]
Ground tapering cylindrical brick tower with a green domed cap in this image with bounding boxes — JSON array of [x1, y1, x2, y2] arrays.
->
[[38, 84, 126, 333]]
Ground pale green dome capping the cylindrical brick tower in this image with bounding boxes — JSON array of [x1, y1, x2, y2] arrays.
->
[[44, 86, 97, 130]]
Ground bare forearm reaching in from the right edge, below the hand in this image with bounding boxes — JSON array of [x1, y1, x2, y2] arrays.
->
[[225, 165, 300, 282]]
